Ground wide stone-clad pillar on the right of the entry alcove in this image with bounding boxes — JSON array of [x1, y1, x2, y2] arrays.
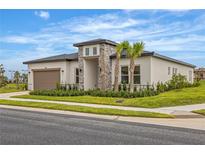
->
[[98, 44, 113, 90]]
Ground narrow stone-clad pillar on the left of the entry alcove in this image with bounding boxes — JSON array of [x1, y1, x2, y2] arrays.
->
[[78, 47, 84, 89]]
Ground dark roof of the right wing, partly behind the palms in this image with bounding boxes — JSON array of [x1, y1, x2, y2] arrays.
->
[[111, 51, 196, 68]]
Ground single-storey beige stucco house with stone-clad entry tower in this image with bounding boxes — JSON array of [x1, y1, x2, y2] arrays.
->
[[24, 39, 195, 90]]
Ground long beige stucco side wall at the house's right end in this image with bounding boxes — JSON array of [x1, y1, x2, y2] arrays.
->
[[151, 57, 194, 83]]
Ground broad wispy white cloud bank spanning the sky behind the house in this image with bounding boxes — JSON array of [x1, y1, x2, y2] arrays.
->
[[0, 10, 205, 72]]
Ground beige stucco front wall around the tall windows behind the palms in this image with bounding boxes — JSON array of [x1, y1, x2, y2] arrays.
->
[[112, 57, 151, 85]]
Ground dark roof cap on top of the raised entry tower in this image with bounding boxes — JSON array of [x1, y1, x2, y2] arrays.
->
[[73, 39, 117, 47]]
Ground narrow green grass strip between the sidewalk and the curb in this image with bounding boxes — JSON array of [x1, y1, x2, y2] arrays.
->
[[0, 100, 174, 118]]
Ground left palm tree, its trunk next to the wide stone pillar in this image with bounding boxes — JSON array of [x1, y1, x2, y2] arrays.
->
[[114, 41, 129, 91]]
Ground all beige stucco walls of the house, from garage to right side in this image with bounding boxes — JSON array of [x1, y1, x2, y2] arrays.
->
[[28, 56, 194, 90]]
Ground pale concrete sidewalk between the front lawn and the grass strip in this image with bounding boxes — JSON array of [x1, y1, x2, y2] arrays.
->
[[0, 91, 205, 118]]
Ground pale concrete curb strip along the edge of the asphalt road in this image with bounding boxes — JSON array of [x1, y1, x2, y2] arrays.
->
[[0, 105, 205, 130]]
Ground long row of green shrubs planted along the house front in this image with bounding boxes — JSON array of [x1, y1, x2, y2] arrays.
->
[[30, 74, 200, 98]]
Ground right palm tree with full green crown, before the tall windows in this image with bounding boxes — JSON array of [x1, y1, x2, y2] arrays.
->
[[127, 42, 145, 92]]
